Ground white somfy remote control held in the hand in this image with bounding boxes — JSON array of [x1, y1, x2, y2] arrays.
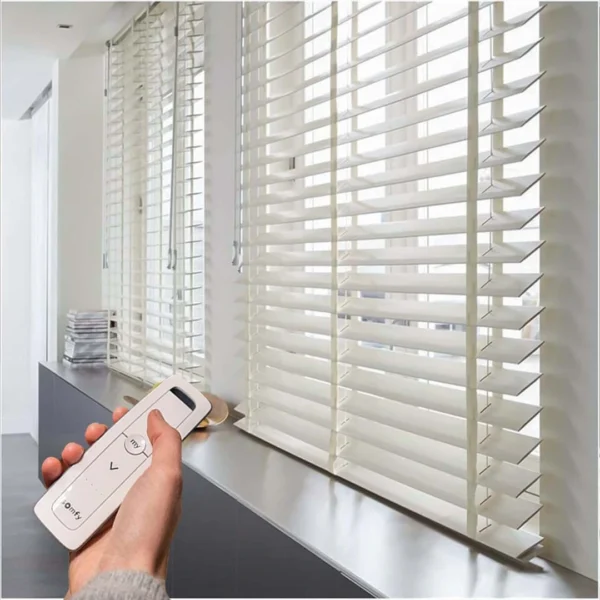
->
[[34, 375, 212, 550]]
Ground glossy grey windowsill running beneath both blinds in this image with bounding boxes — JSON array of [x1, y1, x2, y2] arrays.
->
[[41, 363, 597, 598]]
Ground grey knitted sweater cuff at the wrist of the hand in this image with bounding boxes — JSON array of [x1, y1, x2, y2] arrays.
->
[[71, 571, 169, 600]]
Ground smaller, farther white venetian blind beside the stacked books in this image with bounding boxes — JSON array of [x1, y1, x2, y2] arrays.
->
[[104, 2, 204, 383]]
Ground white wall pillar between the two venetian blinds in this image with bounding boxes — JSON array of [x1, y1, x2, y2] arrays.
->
[[204, 2, 245, 402]]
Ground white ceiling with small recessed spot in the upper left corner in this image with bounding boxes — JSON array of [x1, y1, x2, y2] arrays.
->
[[0, 1, 142, 119]]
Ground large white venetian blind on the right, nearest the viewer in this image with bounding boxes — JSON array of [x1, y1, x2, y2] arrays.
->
[[237, 2, 543, 557]]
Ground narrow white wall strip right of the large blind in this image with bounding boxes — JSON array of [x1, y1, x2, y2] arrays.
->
[[540, 2, 598, 579]]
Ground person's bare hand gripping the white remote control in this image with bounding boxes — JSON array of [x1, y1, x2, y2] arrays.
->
[[42, 408, 182, 596]]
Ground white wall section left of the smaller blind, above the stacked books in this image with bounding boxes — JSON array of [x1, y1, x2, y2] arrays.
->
[[51, 52, 104, 357]]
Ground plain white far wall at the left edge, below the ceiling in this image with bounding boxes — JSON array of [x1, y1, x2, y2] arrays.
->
[[0, 120, 36, 433]]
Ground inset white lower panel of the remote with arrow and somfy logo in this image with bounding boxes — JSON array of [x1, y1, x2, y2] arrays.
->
[[52, 434, 147, 530]]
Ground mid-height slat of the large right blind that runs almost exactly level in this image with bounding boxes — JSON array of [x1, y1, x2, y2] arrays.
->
[[240, 270, 542, 298]]
